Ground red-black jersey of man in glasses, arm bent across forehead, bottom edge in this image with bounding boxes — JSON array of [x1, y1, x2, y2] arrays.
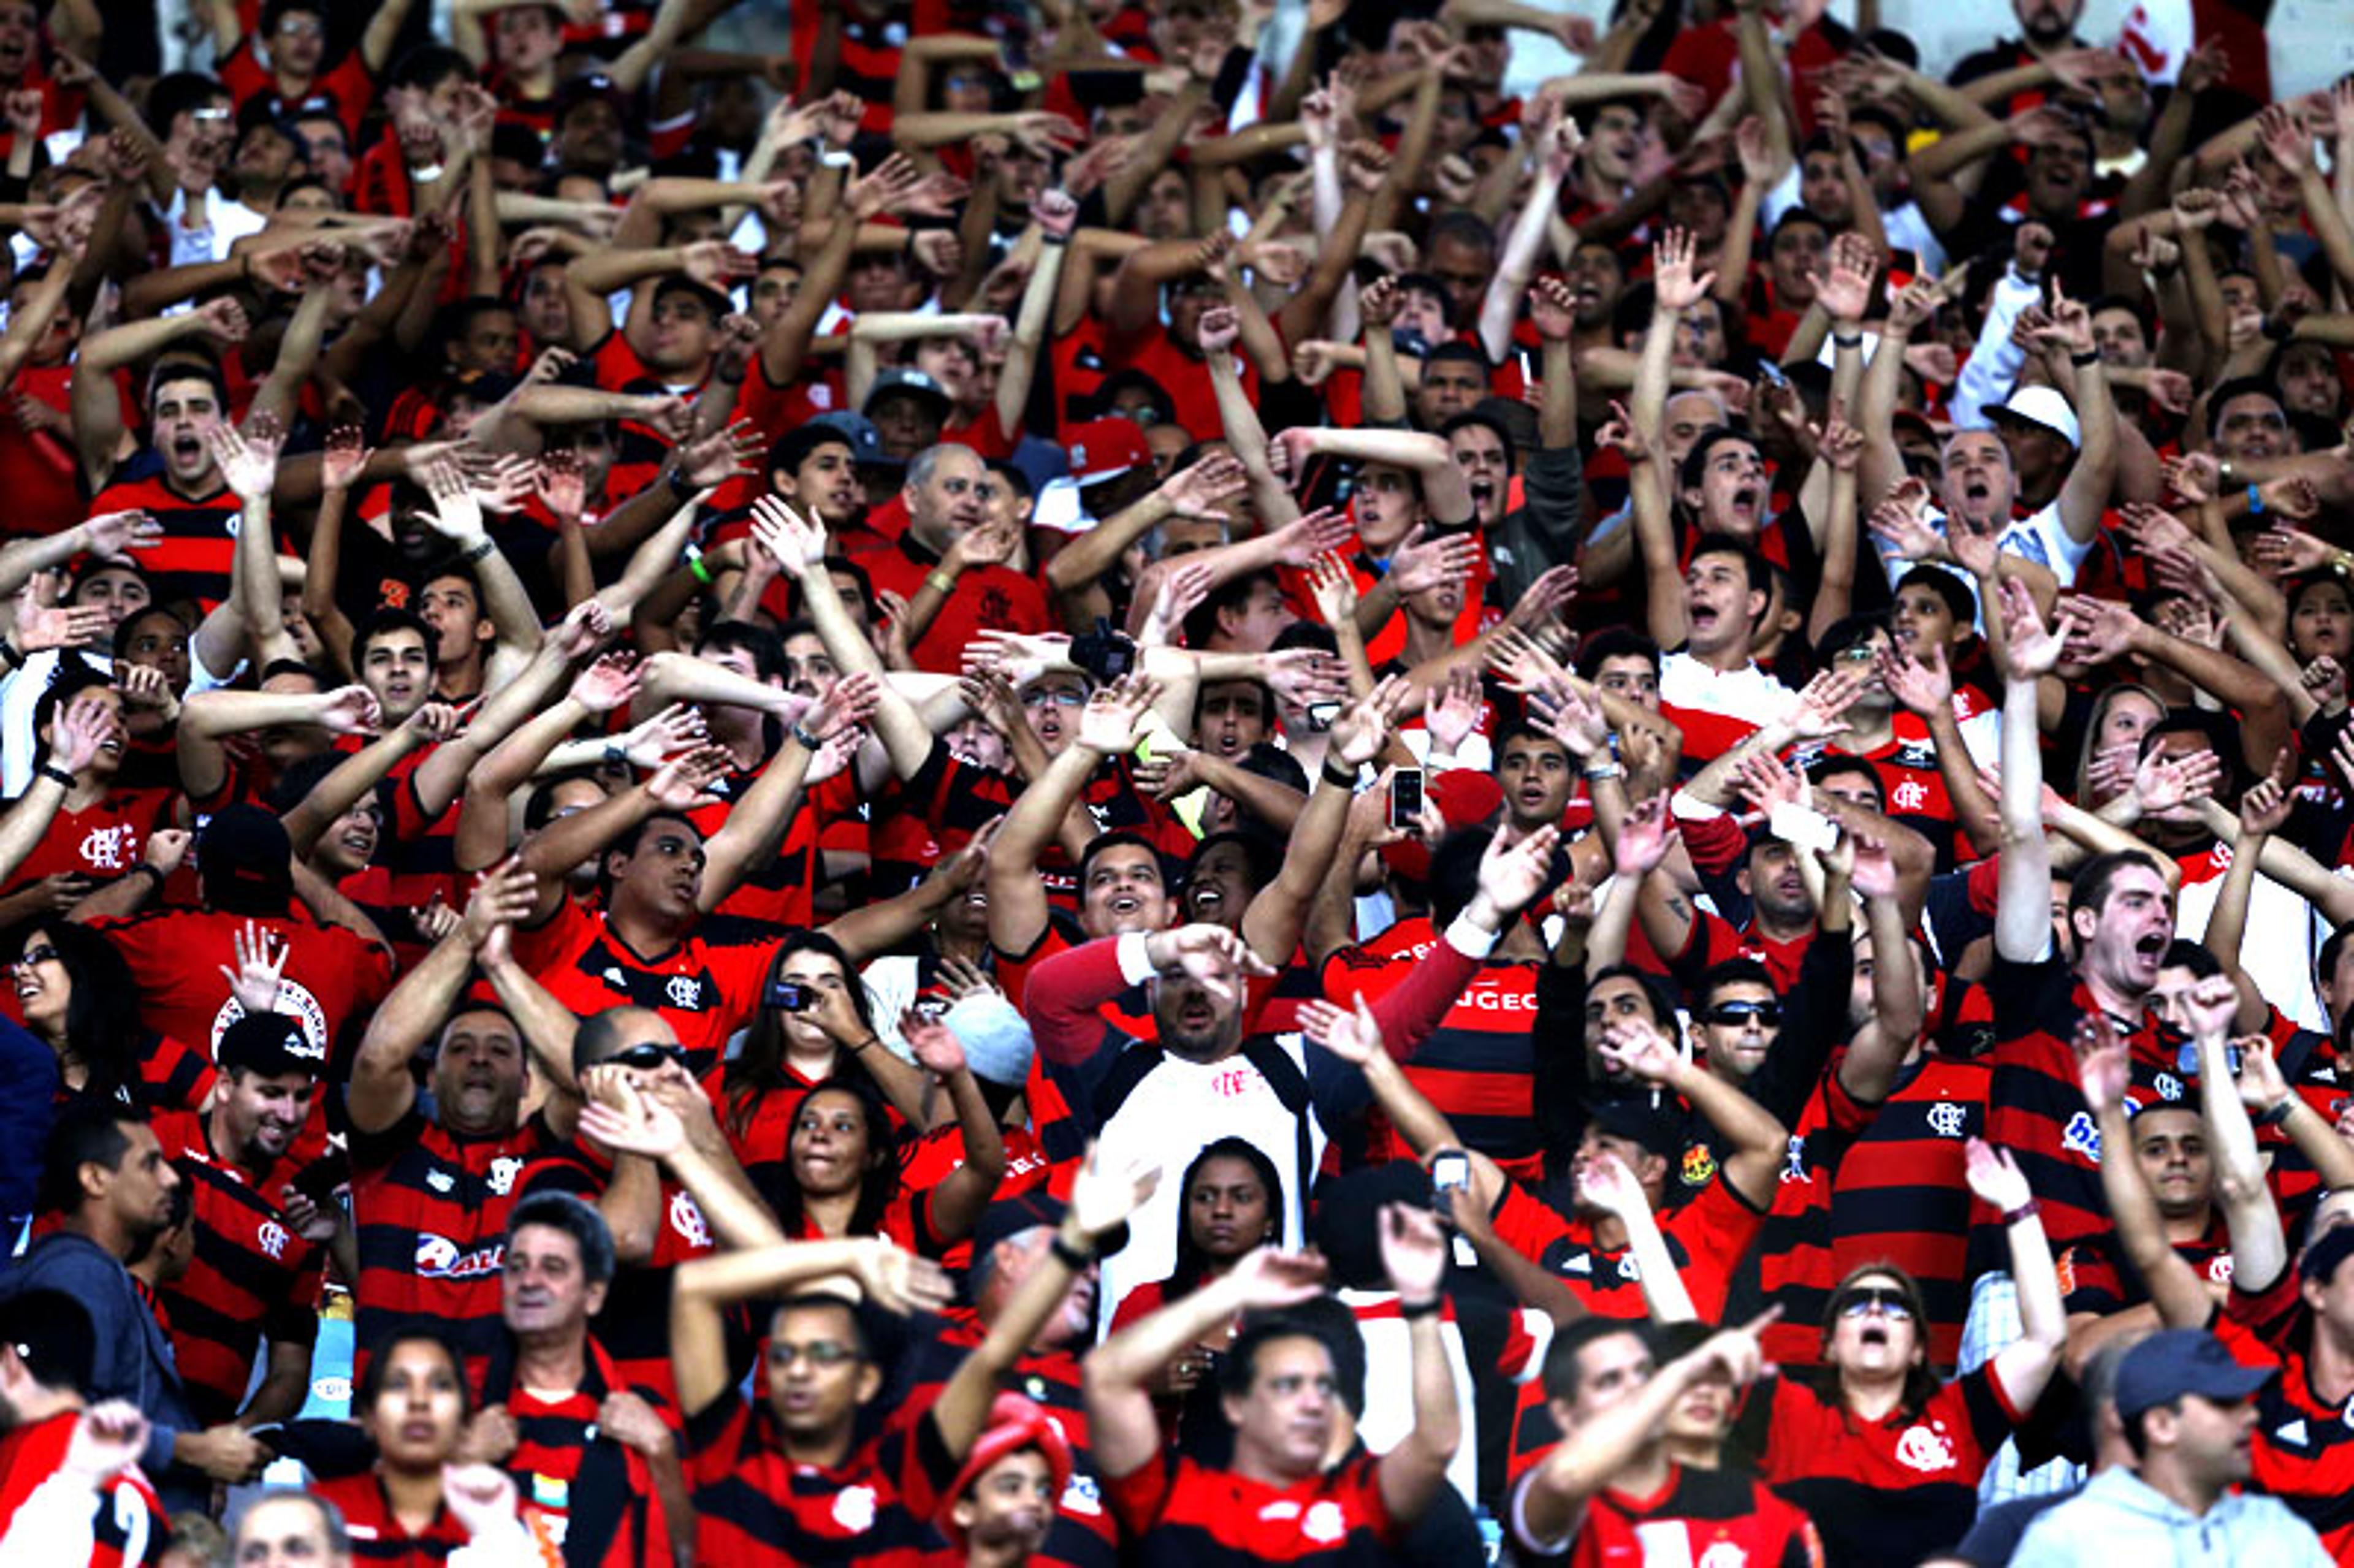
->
[[685, 1389, 958, 1568]]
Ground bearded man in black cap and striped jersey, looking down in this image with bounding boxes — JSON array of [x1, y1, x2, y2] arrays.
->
[[155, 1013, 332, 1429]]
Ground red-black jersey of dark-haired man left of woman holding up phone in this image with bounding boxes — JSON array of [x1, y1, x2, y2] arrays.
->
[[516, 899, 777, 1078]]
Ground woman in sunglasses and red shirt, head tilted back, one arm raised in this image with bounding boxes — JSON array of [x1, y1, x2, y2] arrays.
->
[[1744, 1137, 2067, 1568]]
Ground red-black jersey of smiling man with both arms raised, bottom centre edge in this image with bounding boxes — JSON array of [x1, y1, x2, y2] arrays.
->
[[1109, 1450, 1403, 1568]]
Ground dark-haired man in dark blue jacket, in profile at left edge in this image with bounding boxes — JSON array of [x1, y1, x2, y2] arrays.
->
[[0, 1102, 211, 1507]]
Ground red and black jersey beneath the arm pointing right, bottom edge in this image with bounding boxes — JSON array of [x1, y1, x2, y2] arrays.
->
[[1507, 1464, 1826, 1568]]
